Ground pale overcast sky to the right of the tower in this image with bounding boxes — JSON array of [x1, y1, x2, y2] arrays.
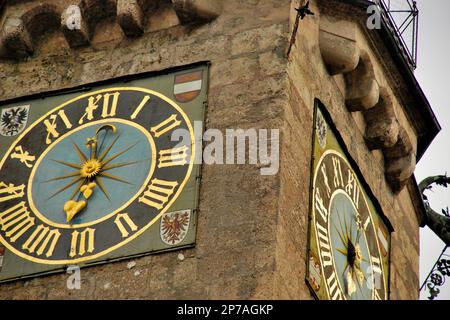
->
[[415, 0, 450, 300]]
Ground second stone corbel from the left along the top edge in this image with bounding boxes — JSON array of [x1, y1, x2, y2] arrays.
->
[[61, 6, 90, 48]]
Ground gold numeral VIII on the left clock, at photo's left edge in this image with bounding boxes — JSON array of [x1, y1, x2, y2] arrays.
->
[[0, 201, 34, 242]]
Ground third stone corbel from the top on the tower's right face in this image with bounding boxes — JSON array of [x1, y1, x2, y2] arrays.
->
[[364, 88, 399, 150]]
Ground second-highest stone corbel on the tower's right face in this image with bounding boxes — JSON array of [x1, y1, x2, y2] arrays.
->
[[345, 54, 380, 112]]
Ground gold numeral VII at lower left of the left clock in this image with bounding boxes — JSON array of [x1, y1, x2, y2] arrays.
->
[[22, 224, 61, 257]]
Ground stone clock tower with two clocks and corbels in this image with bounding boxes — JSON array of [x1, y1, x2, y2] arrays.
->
[[0, 0, 440, 300]]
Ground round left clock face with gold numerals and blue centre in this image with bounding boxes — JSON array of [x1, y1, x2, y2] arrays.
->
[[0, 87, 195, 264]]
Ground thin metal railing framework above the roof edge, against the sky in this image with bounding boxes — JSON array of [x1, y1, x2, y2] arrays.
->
[[372, 0, 419, 69]]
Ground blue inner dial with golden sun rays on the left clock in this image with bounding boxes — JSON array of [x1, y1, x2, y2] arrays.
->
[[30, 119, 153, 225]]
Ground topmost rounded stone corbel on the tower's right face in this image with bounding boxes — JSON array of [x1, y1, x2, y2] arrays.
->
[[319, 30, 360, 75]]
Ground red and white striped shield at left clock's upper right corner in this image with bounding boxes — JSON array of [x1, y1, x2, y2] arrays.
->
[[173, 71, 203, 102]]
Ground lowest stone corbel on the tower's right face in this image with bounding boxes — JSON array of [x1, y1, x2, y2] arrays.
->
[[383, 127, 417, 192]]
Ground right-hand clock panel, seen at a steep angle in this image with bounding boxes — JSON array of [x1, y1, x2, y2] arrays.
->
[[307, 104, 389, 300]]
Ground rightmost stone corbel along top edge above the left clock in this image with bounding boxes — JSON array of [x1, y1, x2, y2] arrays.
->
[[172, 0, 223, 24]]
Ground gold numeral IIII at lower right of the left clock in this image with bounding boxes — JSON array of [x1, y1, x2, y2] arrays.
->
[[139, 178, 178, 210]]
